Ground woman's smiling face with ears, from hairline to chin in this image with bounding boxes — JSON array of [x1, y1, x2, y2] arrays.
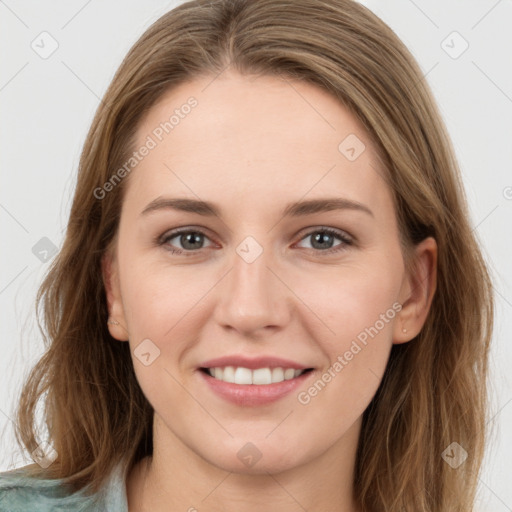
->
[[104, 73, 435, 472]]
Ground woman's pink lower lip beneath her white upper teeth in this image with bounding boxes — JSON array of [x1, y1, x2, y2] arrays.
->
[[198, 370, 314, 406]]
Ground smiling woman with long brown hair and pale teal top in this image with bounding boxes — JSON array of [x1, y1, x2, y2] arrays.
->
[[0, 0, 493, 512]]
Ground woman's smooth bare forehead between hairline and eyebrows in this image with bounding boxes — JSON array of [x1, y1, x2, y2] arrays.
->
[[126, 72, 391, 218]]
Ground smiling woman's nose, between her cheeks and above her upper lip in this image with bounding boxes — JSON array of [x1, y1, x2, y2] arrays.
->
[[215, 242, 293, 338]]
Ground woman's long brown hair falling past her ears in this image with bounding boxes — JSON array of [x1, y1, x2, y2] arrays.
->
[[9, 0, 494, 512]]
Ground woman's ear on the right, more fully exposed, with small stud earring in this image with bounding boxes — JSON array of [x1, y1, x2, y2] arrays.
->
[[393, 237, 437, 344]]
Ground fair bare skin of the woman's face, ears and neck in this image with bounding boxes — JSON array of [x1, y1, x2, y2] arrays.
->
[[103, 72, 437, 512]]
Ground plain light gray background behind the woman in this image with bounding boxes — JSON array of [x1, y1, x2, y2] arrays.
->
[[0, 0, 512, 512]]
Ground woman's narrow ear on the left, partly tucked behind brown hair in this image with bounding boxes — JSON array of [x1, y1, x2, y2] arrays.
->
[[101, 248, 129, 341]]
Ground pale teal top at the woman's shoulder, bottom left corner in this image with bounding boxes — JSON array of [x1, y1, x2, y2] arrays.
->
[[0, 464, 128, 512]]
